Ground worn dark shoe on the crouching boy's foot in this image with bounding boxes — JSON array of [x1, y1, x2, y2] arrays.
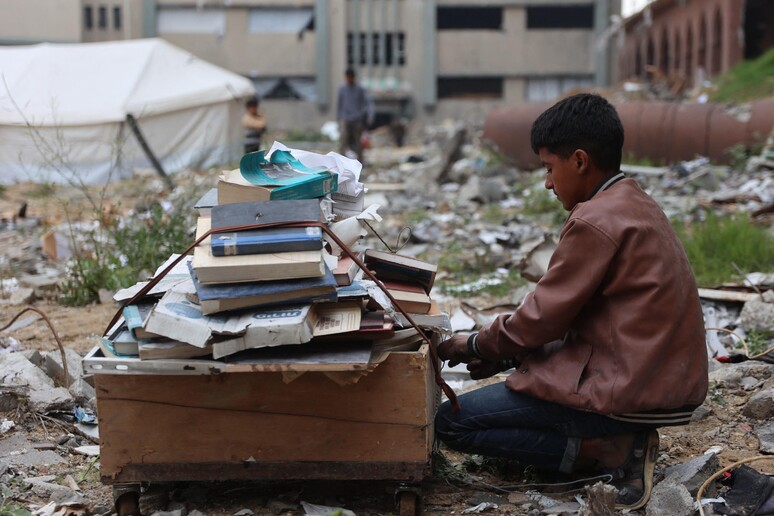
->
[[606, 430, 658, 510]]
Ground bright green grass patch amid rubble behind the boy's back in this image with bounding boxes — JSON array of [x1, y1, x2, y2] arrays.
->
[[672, 213, 774, 287]]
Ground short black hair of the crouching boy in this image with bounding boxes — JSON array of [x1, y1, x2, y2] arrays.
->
[[531, 93, 624, 174]]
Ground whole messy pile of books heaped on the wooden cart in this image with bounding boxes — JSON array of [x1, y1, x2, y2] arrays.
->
[[100, 147, 450, 365]]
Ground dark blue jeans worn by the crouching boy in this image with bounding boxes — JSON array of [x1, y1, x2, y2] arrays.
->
[[435, 383, 650, 473]]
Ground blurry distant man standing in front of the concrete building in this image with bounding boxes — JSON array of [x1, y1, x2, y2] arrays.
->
[[336, 68, 374, 163]]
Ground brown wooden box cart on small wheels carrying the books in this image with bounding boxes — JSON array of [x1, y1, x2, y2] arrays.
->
[[84, 344, 440, 514]]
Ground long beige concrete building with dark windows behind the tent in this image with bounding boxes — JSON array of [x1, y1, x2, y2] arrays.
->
[[0, 0, 621, 129]]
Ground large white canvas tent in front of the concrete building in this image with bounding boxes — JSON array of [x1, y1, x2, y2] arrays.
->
[[0, 39, 254, 184]]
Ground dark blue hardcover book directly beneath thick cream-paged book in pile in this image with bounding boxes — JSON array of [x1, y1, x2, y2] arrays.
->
[[189, 264, 338, 315]]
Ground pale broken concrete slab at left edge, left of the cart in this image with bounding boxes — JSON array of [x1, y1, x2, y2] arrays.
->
[[0, 353, 73, 413]]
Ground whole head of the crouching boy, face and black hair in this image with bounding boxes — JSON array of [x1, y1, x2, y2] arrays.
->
[[531, 93, 624, 211]]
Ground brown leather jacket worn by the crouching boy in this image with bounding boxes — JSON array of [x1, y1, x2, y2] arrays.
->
[[477, 179, 708, 415]]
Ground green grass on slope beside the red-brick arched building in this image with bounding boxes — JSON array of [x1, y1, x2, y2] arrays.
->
[[710, 48, 774, 102]]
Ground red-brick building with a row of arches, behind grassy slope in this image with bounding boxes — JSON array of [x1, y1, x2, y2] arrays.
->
[[619, 0, 774, 84]]
